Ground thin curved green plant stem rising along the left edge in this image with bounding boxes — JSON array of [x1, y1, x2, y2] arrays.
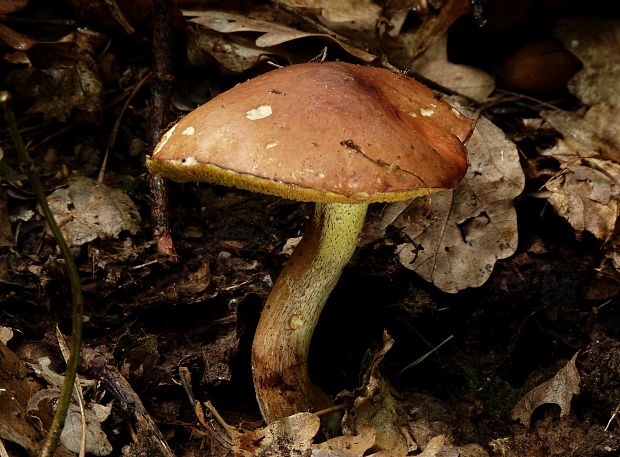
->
[[0, 91, 84, 457]]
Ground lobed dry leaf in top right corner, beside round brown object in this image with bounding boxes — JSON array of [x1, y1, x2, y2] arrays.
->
[[554, 18, 620, 106]]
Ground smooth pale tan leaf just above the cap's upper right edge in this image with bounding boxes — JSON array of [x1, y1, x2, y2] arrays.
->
[[411, 35, 495, 103]]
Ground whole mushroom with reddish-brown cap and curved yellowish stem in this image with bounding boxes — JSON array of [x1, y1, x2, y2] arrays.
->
[[147, 62, 473, 421]]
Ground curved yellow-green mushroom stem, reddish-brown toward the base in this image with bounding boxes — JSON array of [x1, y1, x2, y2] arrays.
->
[[252, 203, 368, 422]]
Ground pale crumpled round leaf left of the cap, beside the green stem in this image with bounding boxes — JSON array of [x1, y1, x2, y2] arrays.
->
[[48, 177, 140, 246]]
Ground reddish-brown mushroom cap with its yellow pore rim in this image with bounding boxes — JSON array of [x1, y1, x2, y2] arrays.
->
[[147, 62, 473, 203]]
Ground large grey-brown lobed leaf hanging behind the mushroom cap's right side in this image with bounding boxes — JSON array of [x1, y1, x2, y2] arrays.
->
[[381, 118, 525, 293]]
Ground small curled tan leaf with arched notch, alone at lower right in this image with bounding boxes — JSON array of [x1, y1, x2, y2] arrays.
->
[[512, 353, 581, 427]]
